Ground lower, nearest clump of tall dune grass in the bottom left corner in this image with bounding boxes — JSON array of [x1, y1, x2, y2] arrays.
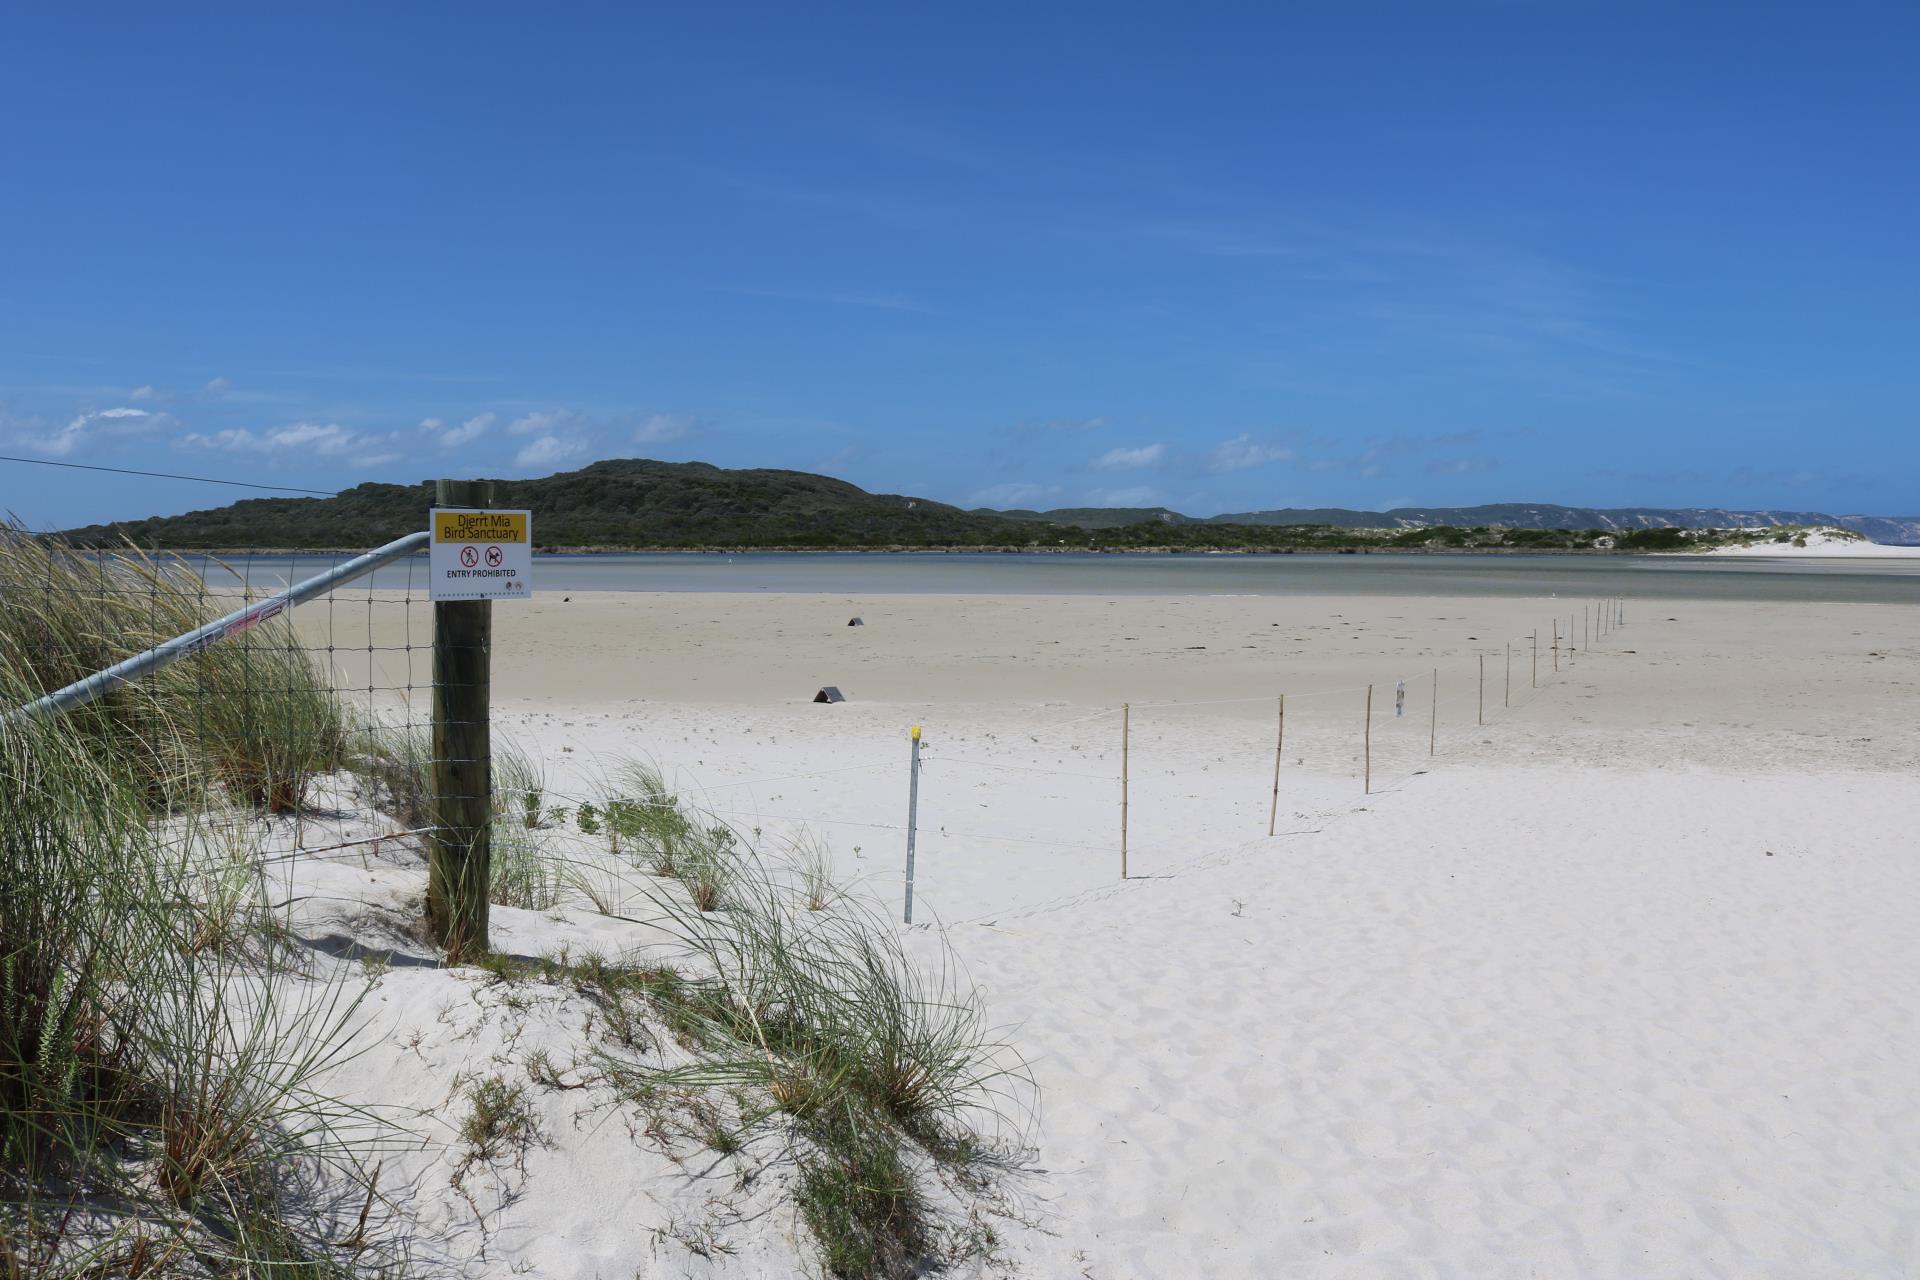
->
[[0, 706, 389, 1276]]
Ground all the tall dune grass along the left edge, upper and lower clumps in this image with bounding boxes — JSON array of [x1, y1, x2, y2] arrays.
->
[[0, 530, 393, 1278]]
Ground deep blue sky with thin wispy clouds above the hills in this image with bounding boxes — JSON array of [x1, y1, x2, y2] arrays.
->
[[0, 0, 1920, 528]]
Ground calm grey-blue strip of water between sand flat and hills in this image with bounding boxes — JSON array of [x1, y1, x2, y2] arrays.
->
[[191, 553, 1920, 603]]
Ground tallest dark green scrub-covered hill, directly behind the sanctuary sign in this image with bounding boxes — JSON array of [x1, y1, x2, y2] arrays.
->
[[67, 459, 1058, 549]]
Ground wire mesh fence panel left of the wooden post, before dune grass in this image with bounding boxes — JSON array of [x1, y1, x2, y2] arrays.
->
[[0, 530, 432, 818]]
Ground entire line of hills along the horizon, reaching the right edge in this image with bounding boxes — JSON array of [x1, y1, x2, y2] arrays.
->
[[52, 459, 1920, 551]]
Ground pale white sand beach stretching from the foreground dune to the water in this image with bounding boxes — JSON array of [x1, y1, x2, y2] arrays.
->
[[280, 595, 1920, 1280]]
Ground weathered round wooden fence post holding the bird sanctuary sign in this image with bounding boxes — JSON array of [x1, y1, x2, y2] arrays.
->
[[426, 480, 493, 963]]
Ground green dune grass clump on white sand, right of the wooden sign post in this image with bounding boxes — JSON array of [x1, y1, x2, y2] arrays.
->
[[587, 816, 1037, 1278]]
